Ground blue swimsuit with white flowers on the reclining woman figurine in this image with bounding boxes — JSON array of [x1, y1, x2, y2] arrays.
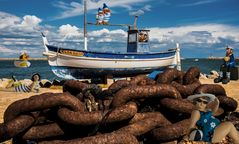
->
[[196, 111, 220, 142]]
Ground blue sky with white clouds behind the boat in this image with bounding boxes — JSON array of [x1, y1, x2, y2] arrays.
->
[[0, 0, 239, 58]]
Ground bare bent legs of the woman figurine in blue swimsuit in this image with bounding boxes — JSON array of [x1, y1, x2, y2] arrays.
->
[[212, 122, 239, 144]]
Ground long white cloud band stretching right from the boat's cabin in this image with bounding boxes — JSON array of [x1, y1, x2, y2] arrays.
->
[[150, 24, 239, 44]]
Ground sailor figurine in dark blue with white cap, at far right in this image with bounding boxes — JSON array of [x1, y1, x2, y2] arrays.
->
[[214, 46, 235, 84]]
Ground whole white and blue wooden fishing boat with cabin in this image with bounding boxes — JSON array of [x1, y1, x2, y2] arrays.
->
[[42, 0, 180, 79]]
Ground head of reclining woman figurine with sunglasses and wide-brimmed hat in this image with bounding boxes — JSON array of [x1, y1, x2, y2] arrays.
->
[[187, 93, 215, 110]]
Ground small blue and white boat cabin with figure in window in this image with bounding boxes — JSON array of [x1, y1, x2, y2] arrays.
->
[[127, 29, 150, 53]]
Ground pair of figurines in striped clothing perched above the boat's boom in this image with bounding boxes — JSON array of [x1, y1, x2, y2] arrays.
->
[[96, 3, 111, 25]]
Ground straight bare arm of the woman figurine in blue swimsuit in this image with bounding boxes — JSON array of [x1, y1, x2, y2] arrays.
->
[[183, 110, 200, 140]]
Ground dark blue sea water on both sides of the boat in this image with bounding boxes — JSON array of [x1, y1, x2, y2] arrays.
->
[[0, 59, 239, 81]]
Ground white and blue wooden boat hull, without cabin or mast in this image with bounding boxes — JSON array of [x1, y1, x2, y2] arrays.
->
[[44, 46, 176, 79]]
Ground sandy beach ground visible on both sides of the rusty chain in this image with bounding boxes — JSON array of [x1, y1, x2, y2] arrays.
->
[[0, 77, 239, 144]]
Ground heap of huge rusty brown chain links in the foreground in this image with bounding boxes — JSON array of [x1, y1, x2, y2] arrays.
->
[[0, 67, 238, 144]]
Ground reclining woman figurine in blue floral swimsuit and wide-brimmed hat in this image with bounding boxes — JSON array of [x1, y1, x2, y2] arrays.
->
[[184, 93, 239, 144]]
